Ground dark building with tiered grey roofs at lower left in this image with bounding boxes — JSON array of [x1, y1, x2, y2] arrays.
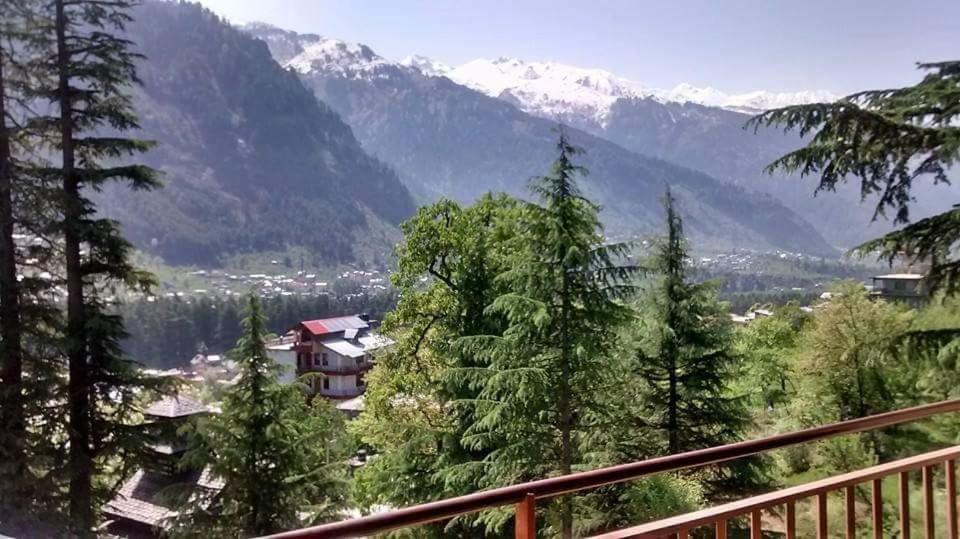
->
[[103, 395, 223, 538]]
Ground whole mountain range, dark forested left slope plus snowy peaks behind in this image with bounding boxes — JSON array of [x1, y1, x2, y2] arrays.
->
[[92, 1, 952, 265]]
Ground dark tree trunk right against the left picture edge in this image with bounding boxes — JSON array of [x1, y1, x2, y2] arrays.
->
[[0, 32, 26, 510]]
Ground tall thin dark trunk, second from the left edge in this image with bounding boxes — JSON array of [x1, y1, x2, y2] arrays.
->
[[56, 0, 94, 537]]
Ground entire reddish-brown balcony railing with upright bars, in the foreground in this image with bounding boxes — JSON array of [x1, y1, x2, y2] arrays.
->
[[271, 399, 960, 539]]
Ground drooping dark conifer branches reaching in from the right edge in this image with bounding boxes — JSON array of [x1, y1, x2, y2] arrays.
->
[[748, 61, 960, 292]]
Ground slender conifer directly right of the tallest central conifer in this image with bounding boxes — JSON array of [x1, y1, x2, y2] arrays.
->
[[636, 189, 760, 494]]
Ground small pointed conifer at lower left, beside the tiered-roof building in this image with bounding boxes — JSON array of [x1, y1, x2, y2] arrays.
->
[[175, 295, 352, 537]]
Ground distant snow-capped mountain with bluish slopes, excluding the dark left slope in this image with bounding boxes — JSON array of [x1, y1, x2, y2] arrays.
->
[[247, 21, 912, 252]]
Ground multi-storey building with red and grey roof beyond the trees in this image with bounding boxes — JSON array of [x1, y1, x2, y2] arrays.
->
[[284, 315, 392, 400]]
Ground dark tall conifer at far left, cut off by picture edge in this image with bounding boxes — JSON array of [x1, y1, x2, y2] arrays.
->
[[0, 0, 63, 534]]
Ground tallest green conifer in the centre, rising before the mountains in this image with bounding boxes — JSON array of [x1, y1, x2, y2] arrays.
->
[[454, 130, 635, 537]]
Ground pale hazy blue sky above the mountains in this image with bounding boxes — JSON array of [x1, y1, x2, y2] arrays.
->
[[195, 0, 960, 93]]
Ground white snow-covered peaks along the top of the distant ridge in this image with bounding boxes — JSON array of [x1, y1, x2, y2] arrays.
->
[[243, 23, 837, 126]]
